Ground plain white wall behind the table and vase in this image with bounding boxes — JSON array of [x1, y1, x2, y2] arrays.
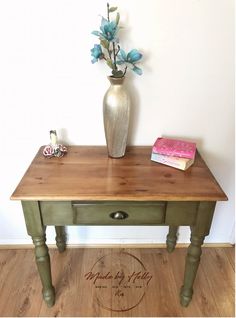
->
[[0, 0, 234, 244]]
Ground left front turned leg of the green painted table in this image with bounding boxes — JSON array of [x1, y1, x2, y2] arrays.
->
[[22, 201, 55, 307]]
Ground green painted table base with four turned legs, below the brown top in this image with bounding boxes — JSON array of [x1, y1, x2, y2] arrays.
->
[[22, 201, 215, 307]]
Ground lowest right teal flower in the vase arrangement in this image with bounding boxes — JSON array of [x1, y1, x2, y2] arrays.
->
[[117, 49, 143, 75]]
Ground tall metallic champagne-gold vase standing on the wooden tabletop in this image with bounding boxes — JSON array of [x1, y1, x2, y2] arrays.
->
[[103, 76, 130, 158]]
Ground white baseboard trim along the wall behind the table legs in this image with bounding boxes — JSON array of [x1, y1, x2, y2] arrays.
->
[[0, 243, 234, 250]]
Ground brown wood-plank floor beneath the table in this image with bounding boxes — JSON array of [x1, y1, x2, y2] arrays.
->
[[0, 247, 235, 317]]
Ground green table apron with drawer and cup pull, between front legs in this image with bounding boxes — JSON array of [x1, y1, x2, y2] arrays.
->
[[39, 201, 199, 226]]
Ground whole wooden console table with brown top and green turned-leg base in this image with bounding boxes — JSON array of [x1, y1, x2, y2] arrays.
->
[[11, 146, 227, 306]]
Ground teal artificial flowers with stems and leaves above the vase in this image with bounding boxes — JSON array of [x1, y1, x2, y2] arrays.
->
[[91, 3, 142, 78]]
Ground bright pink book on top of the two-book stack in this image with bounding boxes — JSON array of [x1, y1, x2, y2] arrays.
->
[[152, 138, 196, 159]]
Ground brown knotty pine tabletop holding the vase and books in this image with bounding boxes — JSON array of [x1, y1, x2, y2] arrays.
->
[[11, 146, 227, 201]]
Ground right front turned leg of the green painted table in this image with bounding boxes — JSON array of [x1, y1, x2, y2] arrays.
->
[[180, 202, 215, 307]]
